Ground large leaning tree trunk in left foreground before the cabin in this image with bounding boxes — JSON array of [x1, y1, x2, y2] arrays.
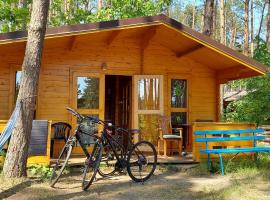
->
[[3, 0, 49, 178]]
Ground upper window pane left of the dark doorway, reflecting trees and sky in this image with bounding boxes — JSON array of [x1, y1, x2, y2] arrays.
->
[[77, 77, 99, 109]]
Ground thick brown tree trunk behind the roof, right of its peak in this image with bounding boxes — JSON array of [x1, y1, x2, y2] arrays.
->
[[203, 0, 214, 36]]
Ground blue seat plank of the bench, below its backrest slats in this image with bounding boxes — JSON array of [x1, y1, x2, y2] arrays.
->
[[200, 147, 270, 154]]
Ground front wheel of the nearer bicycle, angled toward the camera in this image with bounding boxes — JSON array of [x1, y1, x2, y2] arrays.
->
[[82, 142, 103, 190]]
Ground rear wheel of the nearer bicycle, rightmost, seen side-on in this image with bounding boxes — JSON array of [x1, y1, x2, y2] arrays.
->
[[127, 141, 157, 182]]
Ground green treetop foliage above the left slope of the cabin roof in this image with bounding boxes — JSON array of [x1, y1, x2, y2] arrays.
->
[[0, 0, 171, 32]]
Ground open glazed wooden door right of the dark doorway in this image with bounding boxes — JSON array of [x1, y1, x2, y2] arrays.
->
[[133, 75, 164, 145]]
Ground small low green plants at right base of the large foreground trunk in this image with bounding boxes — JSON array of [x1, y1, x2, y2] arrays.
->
[[28, 164, 52, 179]]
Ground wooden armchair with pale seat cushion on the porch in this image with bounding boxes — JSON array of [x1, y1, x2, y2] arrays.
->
[[158, 116, 183, 157]]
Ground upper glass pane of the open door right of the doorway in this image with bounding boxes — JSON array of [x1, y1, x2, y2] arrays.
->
[[138, 78, 160, 110]]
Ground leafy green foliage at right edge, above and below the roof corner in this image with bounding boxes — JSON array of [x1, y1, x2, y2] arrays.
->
[[224, 38, 270, 124]]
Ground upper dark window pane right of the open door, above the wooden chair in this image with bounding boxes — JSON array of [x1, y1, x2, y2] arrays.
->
[[171, 79, 187, 108]]
